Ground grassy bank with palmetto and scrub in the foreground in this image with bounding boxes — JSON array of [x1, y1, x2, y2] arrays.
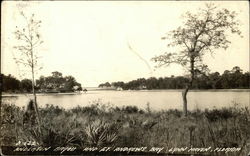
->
[[0, 101, 250, 156]]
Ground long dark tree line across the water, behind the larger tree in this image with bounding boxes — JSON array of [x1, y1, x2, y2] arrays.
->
[[99, 66, 250, 90]]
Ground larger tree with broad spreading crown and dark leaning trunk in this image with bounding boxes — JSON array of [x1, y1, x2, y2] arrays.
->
[[152, 4, 241, 116]]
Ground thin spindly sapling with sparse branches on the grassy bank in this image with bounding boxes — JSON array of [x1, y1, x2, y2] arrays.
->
[[14, 12, 43, 129]]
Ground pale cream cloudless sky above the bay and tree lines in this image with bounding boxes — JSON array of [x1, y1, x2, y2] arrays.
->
[[1, 1, 250, 87]]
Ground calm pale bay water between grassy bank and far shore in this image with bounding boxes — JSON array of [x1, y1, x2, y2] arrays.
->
[[2, 90, 250, 110]]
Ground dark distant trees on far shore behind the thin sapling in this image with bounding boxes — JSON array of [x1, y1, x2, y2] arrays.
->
[[1, 71, 82, 93]]
